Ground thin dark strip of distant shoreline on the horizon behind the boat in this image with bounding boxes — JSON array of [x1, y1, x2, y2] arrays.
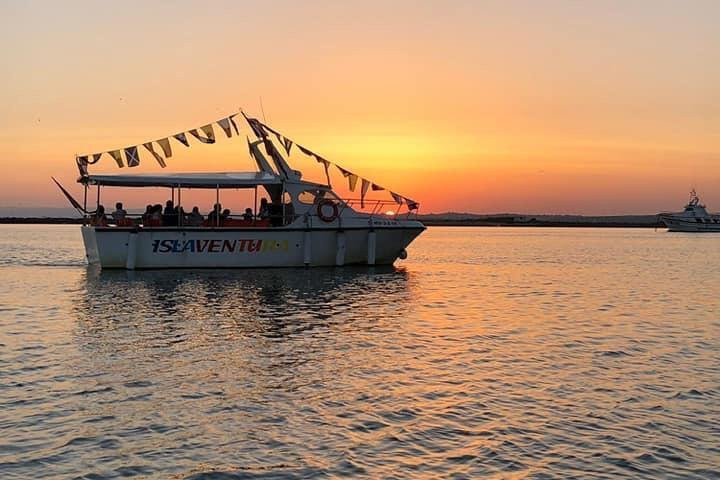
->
[[0, 217, 665, 228]]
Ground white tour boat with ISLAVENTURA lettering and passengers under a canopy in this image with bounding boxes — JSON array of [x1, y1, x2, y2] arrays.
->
[[58, 113, 425, 270]]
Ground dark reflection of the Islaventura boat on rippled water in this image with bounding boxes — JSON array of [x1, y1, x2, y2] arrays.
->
[[77, 266, 410, 336]]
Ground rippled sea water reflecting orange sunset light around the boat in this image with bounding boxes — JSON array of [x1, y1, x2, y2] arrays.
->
[[0, 226, 720, 479]]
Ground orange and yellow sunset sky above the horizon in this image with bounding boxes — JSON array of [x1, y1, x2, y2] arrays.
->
[[0, 0, 720, 214]]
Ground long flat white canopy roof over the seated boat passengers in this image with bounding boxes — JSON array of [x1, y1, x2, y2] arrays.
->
[[78, 172, 283, 188]]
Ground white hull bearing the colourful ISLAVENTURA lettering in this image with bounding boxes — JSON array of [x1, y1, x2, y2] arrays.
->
[[82, 221, 425, 270]]
